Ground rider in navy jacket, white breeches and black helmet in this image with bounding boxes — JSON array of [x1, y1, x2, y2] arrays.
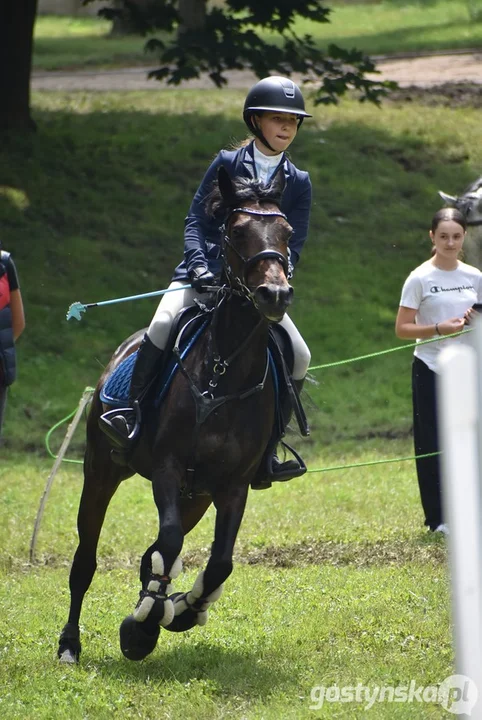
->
[[100, 76, 311, 480]]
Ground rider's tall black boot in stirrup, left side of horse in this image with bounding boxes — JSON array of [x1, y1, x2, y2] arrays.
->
[[99, 334, 164, 450]]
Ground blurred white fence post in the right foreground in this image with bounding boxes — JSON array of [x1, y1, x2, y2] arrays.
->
[[437, 321, 482, 720]]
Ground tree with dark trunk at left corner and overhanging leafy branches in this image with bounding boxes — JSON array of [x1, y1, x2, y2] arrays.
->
[[0, 0, 394, 131]]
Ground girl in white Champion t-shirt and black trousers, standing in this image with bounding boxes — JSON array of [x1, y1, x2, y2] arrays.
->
[[395, 208, 482, 534]]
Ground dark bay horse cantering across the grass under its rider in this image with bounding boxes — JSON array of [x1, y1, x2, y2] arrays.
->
[[58, 168, 293, 662]]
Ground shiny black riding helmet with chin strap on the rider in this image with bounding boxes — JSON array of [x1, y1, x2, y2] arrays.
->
[[243, 75, 311, 150]]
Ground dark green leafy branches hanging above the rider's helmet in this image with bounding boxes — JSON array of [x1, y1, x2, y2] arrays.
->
[[96, 0, 394, 103]]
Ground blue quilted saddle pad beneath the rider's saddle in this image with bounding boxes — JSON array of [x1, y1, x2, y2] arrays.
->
[[100, 319, 209, 408]]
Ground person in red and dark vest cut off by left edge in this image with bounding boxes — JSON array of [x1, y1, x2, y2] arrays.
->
[[0, 247, 25, 439]]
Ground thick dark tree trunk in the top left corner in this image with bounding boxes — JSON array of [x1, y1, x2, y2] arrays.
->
[[0, 0, 37, 131]]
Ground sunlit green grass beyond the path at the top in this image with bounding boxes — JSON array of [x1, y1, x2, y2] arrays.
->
[[34, 0, 482, 70]]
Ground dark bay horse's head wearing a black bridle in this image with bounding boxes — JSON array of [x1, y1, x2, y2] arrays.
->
[[207, 167, 293, 322]]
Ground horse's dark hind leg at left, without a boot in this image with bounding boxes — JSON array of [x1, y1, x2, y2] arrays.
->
[[57, 458, 121, 663]]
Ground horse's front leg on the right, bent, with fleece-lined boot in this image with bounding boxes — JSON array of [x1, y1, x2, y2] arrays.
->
[[165, 486, 248, 632]]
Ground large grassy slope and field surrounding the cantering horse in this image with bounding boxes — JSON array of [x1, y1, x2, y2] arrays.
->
[[0, 76, 482, 720]]
